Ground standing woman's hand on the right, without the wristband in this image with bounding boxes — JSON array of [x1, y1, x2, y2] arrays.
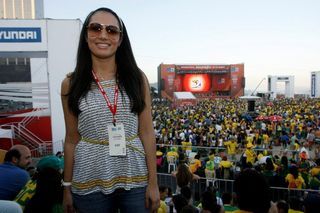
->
[[146, 184, 160, 213]]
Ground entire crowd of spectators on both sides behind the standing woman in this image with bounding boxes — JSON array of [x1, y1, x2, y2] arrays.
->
[[0, 99, 320, 213]]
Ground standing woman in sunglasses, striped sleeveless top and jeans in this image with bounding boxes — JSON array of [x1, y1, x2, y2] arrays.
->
[[61, 8, 160, 212]]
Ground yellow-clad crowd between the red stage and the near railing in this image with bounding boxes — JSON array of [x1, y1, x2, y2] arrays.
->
[[153, 99, 320, 210]]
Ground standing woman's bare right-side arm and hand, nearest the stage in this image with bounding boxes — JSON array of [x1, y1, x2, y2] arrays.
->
[[139, 75, 160, 211]]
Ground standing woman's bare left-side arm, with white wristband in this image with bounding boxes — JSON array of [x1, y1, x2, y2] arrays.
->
[[61, 77, 80, 212]]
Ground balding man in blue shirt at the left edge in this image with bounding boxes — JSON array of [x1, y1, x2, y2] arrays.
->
[[0, 145, 31, 200]]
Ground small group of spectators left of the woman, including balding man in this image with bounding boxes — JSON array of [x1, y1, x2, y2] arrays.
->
[[0, 145, 64, 213]]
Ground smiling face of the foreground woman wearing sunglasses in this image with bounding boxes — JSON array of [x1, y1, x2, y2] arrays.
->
[[87, 11, 121, 59]]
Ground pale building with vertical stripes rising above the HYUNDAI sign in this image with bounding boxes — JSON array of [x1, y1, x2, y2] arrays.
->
[[0, 0, 44, 19]]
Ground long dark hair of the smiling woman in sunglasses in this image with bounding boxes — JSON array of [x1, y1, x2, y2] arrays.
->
[[67, 7, 145, 115]]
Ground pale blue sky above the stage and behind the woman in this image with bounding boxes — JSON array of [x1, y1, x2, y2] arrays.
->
[[44, 0, 320, 93]]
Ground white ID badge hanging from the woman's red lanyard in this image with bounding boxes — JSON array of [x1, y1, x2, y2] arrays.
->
[[108, 123, 126, 156]]
